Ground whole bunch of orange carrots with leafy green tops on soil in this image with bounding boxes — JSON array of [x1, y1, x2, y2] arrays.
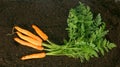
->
[[14, 2, 116, 62]]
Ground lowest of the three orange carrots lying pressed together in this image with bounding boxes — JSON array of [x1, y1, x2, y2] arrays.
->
[[14, 38, 44, 50]]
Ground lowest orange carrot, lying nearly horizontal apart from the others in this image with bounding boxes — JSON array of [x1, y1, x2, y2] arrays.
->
[[21, 52, 46, 60]]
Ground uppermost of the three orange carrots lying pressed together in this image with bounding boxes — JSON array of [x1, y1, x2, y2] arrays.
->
[[14, 26, 41, 41]]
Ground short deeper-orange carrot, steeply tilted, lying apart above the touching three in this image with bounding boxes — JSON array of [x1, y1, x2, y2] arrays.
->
[[32, 25, 48, 41]]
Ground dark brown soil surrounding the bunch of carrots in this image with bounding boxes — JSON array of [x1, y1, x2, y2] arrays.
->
[[0, 0, 120, 67]]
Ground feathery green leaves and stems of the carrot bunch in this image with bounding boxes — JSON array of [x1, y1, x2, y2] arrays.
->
[[42, 3, 116, 62]]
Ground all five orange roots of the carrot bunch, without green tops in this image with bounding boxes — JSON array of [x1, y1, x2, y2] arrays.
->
[[14, 25, 49, 60]]
